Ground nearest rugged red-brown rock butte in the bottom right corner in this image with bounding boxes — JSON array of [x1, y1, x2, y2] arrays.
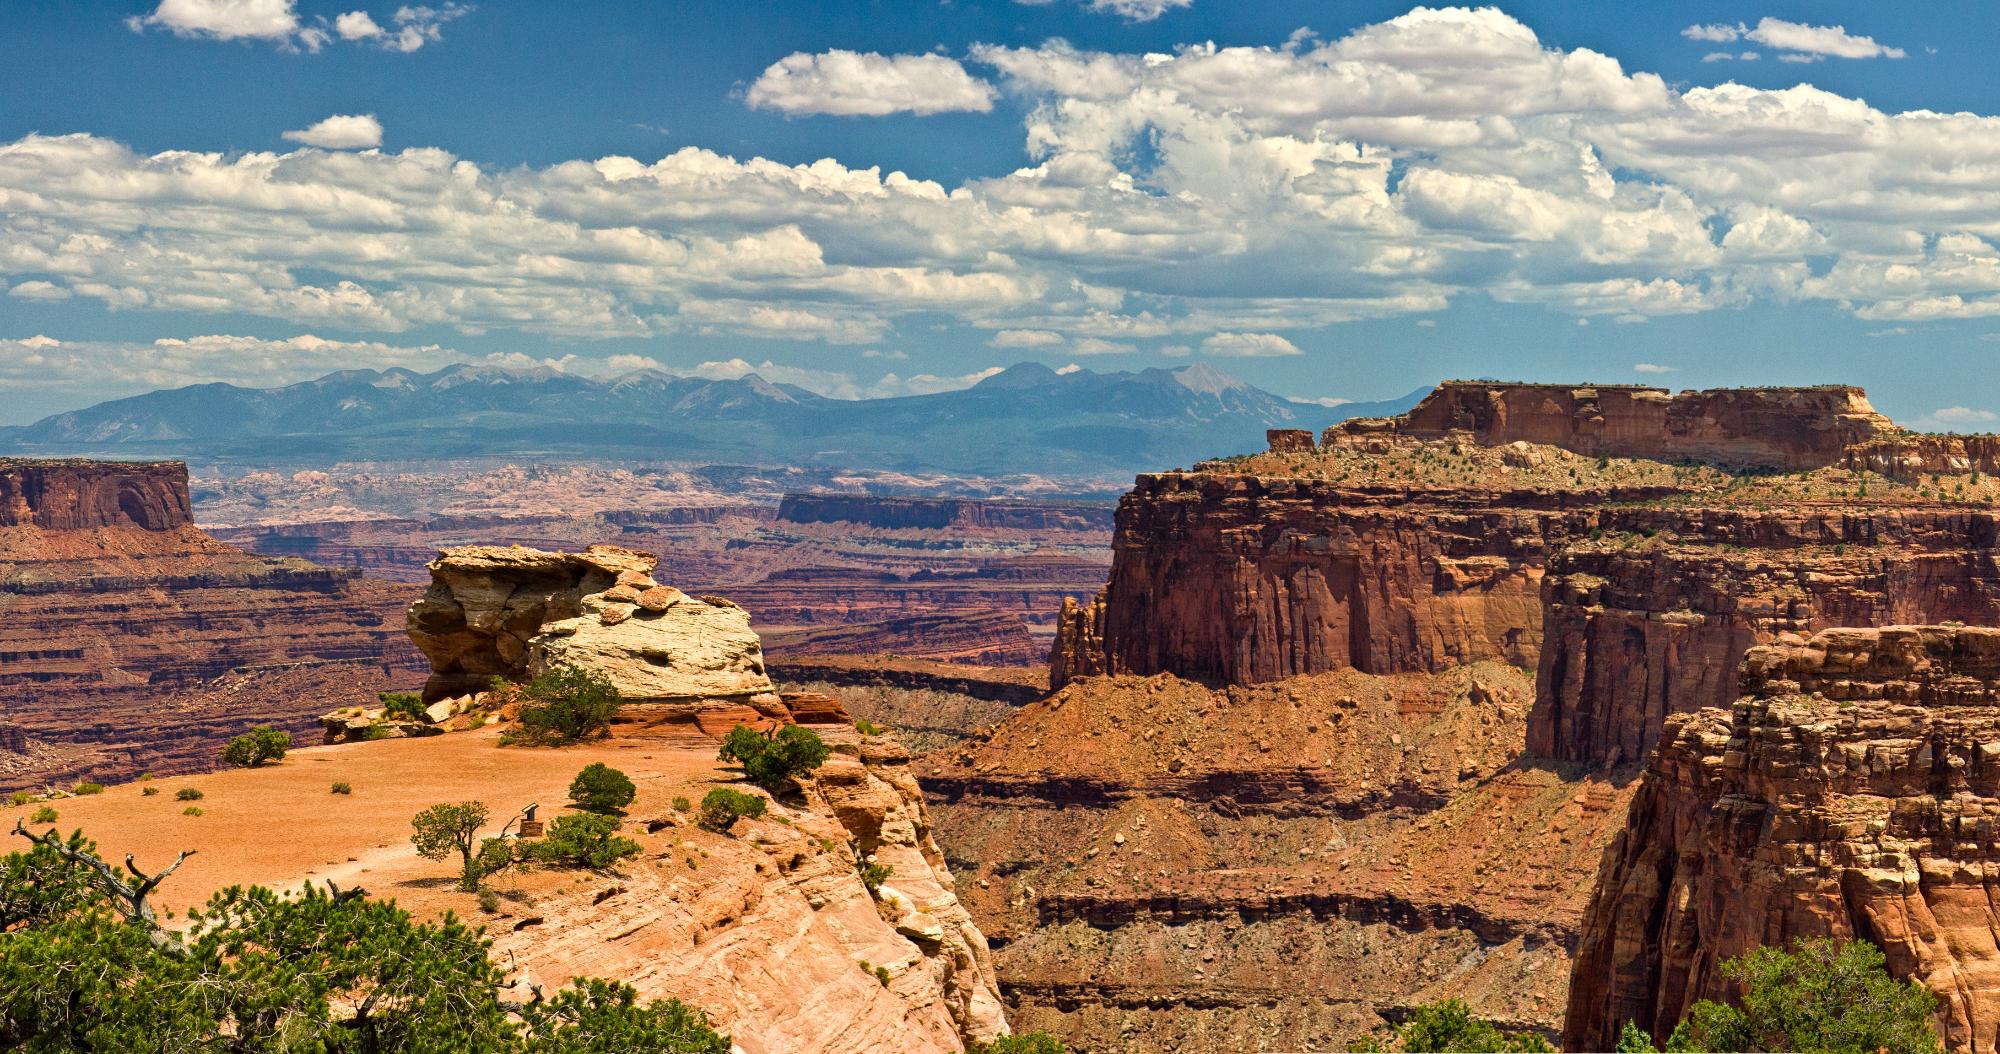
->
[[1564, 626, 2000, 1052]]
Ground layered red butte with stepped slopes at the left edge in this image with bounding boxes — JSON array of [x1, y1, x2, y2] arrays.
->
[[0, 460, 422, 790]]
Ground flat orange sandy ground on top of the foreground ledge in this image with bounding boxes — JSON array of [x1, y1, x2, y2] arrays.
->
[[0, 728, 734, 920]]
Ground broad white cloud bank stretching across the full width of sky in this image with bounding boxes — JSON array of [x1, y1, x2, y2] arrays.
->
[[15, 0, 2000, 354]]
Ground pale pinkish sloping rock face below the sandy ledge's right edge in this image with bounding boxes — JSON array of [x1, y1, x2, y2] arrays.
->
[[496, 696, 1006, 1054]]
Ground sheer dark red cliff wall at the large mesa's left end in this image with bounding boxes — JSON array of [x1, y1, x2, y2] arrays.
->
[[1054, 474, 1566, 684]]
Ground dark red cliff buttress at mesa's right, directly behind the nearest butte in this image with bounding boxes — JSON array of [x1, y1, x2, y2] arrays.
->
[[1528, 506, 2000, 766]]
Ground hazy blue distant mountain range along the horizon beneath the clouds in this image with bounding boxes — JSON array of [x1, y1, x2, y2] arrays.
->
[[0, 362, 1424, 476]]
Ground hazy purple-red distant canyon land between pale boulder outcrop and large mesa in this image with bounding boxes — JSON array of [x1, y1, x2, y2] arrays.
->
[[214, 482, 1110, 666]]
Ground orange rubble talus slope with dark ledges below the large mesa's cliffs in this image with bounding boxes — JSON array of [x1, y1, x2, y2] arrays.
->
[[918, 662, 1628, 1054]]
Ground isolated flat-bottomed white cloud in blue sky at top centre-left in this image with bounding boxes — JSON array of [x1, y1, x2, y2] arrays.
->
[[744, 48, 998, 116]]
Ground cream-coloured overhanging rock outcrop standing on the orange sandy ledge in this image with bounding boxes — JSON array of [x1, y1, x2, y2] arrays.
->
[[410, 546, 772, 704]]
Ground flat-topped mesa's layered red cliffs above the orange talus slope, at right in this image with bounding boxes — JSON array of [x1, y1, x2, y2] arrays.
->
[[1050, 382, 2000, 768]]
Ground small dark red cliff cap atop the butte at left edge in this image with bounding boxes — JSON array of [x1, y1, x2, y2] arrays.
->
[[0, 458, 194, 532]]
